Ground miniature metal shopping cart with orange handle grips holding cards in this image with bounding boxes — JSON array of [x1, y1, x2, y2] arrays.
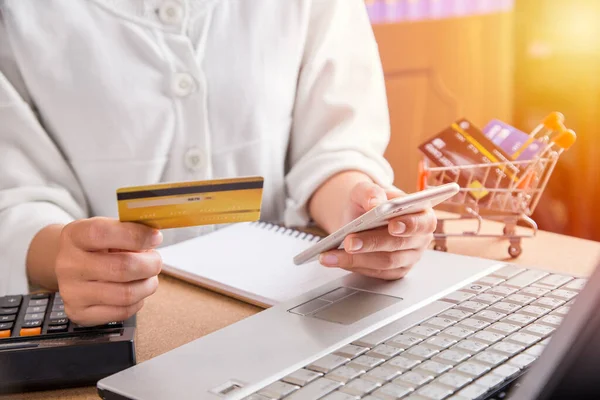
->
[[419, 113, 576, 258]]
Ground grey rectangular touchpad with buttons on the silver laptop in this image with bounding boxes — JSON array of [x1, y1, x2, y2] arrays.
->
[[289, 287, 402, 325]]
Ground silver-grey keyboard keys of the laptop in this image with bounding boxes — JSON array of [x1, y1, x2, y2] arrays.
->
[[246, 266, 586, 400]]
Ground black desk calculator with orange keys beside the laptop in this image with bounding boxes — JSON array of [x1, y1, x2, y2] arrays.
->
[[0, 293, 135, 394]]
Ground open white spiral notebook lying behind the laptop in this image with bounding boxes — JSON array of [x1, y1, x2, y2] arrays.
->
[[159, 222, 348, 307]]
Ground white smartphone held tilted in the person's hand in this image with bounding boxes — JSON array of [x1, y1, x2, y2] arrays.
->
[[294, 183, 460, 265]]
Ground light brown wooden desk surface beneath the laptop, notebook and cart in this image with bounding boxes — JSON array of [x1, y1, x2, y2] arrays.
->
[[1, 223, 600, 400]]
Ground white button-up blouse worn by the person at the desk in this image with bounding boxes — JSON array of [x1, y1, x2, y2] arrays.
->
[[0, 0, 392, 295]]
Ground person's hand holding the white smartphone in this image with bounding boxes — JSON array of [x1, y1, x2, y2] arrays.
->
[[319, 181, 437, 280]]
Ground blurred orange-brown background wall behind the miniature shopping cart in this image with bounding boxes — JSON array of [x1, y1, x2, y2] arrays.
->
[[366, 0, 600, 240]]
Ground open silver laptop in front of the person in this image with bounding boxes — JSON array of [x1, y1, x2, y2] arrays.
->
[[98, 251, 600, 400]]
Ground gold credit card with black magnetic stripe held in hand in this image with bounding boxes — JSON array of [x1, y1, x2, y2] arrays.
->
[[117, 176, 264, 229]]
